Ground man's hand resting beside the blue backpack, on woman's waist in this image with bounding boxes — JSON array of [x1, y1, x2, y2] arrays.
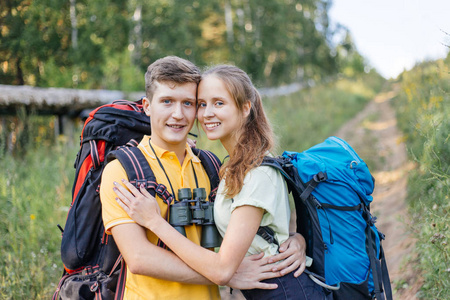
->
[[268, 233, 306, 277]]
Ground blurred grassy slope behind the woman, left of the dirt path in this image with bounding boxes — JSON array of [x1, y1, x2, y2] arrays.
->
[[196, 75, 379, 158]]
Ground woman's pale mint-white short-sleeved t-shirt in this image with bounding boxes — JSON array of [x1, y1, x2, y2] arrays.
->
[[214, 166, 294, 256]]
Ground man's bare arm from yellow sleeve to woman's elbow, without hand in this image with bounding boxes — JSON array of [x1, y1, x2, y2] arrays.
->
[[111, 223, 213, 284]]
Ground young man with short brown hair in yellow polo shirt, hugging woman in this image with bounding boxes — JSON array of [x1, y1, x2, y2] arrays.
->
[[100, 56, 304, 299]]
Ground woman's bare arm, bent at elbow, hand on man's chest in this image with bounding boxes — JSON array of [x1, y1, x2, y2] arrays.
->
[[115, 181, 264, 285]]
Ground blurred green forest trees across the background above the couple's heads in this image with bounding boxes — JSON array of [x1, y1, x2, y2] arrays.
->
[[0, 0, 358, 91]]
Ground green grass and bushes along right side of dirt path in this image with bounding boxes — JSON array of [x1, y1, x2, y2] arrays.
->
[[396, 55, 450, 299]]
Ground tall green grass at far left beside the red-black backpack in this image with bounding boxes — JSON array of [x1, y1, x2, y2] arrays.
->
[[0, 134, 75, 299]]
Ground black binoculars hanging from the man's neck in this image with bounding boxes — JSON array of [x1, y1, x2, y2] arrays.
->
[[169, 188, 222, 248]]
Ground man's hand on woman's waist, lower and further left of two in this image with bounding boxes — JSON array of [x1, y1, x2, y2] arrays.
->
[[228, 253, 280, 290]]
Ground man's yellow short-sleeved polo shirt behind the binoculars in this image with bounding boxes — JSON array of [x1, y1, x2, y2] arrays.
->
[[100, 136, 220, 300]]
